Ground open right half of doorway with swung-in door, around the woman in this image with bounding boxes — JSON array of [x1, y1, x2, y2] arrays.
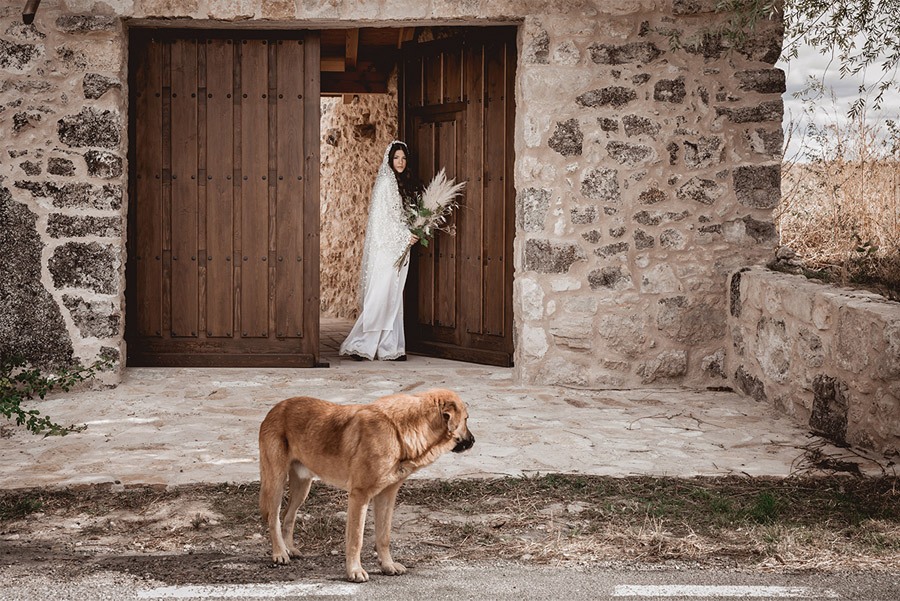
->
[[320, 27, 516, 366]]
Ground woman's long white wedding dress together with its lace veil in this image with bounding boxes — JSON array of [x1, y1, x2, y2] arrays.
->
[[340, 140, 410, 361]]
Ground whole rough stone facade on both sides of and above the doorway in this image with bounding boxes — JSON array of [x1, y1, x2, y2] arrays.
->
[[0, 0, 784, 387]]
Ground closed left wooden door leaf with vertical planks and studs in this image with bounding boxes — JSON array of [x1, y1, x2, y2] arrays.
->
[[126, 30, 319, 366]]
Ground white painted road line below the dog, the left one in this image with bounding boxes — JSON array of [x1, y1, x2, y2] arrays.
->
[[138, 582, 359, 599]]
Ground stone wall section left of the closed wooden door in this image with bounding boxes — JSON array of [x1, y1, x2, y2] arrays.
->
[[0, 2, 127, 381]]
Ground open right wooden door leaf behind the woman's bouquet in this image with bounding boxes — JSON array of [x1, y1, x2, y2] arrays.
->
[[400, 27, 516, 365]]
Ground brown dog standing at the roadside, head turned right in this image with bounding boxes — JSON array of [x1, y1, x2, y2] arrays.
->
[[259, 389, 475, 582]]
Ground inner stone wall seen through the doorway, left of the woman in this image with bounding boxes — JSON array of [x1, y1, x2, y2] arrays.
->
[[319, 90, 397, 319]]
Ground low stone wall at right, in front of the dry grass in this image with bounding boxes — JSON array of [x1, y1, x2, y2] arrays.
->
[[727, 267, 900, 455]]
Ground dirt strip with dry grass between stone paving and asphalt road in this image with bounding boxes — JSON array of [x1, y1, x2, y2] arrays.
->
[[0, 475, 900, 584]]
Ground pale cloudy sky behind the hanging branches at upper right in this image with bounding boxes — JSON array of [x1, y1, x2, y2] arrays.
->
[[776, 36, 900, 160]]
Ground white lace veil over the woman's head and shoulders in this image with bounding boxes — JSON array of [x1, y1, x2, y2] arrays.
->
[[359, 140, 410, 306]]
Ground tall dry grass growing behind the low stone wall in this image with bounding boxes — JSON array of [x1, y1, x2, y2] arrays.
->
[[775, 103, 900, 300]]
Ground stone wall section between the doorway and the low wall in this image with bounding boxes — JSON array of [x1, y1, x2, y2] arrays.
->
[[514, 1, 784, 387]]
